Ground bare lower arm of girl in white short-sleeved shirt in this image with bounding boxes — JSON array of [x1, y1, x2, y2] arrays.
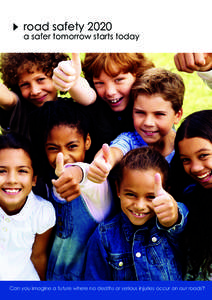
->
[[31, 228, 52, 280]]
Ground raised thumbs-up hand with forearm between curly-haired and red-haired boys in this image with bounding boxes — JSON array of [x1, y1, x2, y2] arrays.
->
[[52, 53, 96, 105]]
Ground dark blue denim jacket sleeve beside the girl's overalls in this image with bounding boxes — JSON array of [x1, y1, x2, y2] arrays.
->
[[84, 226, 112, 281]]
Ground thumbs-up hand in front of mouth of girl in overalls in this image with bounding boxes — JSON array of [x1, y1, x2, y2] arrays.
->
[[52, 153, 83, 201]]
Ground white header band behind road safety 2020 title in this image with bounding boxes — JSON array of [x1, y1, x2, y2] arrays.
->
[[0, 0, 212, 52]]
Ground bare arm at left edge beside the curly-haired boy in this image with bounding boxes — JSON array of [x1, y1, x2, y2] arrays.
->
[[0, 83, 18, 110]]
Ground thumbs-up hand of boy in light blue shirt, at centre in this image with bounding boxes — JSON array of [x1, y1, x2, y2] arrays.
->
[[88, 144, 112, 183]]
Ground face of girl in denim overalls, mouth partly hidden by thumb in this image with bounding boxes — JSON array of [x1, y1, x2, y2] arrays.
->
[[45, 125, 91, 169]]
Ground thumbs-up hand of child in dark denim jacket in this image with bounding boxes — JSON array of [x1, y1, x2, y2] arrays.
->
[[152, 173, 178, 227]]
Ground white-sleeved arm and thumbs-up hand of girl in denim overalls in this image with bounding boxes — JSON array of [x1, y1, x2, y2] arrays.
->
[[52, 153, 112, 222]]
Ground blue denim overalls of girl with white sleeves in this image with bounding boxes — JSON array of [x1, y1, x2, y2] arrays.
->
[[46, 189, 98, 280]]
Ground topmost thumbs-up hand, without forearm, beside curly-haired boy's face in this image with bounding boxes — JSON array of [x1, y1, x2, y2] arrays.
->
[[52, 53, 82, 92]]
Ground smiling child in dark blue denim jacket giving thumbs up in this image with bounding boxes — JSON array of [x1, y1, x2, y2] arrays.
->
[[85, 146, 188, 281]]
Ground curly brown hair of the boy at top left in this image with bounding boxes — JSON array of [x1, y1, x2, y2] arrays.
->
[[0, 53, 69, 93]]
